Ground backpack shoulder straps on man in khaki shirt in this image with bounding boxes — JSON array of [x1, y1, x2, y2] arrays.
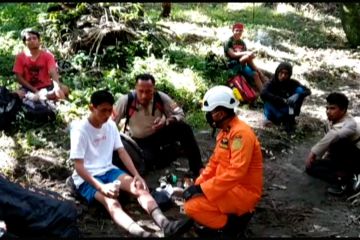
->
[[124, 91, 165, 132]]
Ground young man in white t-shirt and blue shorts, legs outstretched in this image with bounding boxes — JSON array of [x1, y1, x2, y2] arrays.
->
[[70, 90, 191, 237]]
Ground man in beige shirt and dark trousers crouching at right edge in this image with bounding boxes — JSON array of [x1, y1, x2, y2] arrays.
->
[[306, 92, 360, 195]]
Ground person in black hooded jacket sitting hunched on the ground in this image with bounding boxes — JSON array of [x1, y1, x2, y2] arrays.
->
[[260, 62, 311, 132]]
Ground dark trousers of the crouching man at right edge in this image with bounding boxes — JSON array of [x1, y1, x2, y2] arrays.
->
[[306, 139, 360, 183]]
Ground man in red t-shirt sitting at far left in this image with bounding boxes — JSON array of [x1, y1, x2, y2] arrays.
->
[[13, 28, 69, 100]]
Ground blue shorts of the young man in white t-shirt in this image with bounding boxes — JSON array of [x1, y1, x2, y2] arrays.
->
[[77, 168, 125, 204]]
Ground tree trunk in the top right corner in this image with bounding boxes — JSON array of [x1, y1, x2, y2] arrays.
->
[[340, 2, 360, 47]]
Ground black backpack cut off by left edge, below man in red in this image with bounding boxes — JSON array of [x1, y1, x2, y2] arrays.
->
[[0, 87, 21, 130]]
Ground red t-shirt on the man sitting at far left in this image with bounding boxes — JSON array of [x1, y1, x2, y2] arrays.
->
[[13, 50, 57, 89]]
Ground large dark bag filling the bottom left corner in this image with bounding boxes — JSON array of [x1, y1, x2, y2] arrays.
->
[[0, 175, 79, 238]]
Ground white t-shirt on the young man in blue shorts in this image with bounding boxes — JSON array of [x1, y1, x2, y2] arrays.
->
[[70, 118, 123, 188]]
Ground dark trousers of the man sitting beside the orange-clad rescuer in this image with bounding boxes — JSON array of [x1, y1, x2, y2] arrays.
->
[[134, 121, 203, 176]]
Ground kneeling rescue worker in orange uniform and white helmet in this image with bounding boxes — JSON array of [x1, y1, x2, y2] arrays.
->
[[183, 86, 263, 236]]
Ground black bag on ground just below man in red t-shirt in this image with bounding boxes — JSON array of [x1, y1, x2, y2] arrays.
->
[[23, 99, 56, 124]]
